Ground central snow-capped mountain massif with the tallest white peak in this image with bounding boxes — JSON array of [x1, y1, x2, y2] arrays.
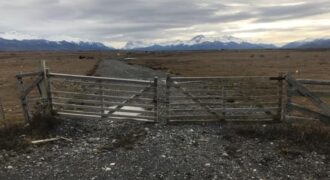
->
[[124, 35, 276, 51]]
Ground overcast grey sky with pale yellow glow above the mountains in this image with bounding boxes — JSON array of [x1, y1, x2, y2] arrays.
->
[[0, 0, 330, 47]]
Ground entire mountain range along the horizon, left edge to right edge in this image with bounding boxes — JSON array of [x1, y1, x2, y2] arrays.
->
[[0, 35, 330, 51]]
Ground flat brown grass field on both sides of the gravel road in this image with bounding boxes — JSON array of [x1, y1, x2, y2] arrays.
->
[[0, 50, 330, 125]]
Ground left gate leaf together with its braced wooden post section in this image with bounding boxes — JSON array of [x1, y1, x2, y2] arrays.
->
[[16, 62, 159, 123]]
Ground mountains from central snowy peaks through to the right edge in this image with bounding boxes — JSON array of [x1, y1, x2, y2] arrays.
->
[[124, 35, 330, 51]]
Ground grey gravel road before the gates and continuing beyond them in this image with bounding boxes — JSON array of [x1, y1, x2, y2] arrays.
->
[[0, 60, 330, 180]]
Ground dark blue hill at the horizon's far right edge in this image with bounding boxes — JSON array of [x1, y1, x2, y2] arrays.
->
[[282, 38, 330, 49]]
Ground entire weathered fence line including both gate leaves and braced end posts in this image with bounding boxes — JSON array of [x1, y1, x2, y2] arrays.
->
[[16, 64, 330, 123]]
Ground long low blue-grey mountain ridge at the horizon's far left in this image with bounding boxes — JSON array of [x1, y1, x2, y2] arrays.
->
[[0, 38, 113, 51]]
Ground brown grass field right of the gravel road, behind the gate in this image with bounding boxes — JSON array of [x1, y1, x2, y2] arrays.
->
[[129, 50, 330, 79]]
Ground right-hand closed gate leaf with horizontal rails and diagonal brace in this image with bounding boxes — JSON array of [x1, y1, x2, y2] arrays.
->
[[166, 75, 284, 122]]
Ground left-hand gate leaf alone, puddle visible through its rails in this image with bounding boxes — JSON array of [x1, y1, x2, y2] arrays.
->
[[48, 73, 158, 122]]
